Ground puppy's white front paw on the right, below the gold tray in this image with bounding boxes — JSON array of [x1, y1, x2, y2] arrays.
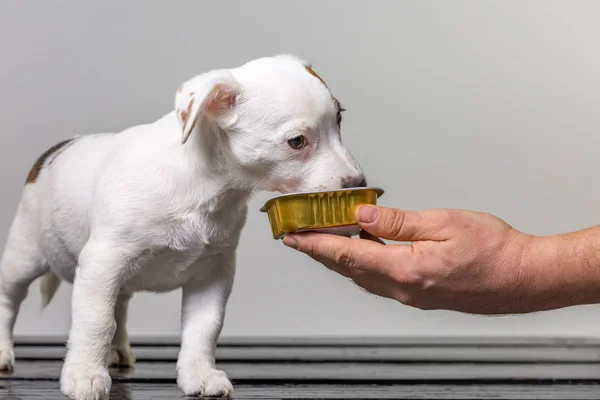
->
[[177, 368, 233, 397]]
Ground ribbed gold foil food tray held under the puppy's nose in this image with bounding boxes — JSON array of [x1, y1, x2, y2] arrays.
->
[[260, 187, 384, 239]]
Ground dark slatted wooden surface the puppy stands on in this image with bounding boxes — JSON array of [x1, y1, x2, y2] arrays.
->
[[0, 338, 600, 400]]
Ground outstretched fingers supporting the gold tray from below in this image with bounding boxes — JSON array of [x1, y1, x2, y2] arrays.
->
[[283, 233, 403, 276]]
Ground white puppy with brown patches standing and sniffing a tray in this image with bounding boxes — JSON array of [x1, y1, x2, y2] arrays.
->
[[0, 55, 366, 400]]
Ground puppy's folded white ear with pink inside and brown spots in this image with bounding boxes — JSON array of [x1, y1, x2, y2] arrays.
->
[[175, 70, 240, 144]]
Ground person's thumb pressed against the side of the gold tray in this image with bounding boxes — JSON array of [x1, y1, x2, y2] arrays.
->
[[356, 205, 446, 242]]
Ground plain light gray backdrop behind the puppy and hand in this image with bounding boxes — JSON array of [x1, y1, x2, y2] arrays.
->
[[0, 0, 600, 336]]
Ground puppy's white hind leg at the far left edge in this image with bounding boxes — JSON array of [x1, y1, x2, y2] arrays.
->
[[0, 203, 48, 370]]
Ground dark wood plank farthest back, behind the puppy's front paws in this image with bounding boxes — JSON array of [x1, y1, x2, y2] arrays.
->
[[16, 344, 600, 363]]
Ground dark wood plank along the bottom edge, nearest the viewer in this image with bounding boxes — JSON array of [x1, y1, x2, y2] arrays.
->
[[0, 381, 600, 400]]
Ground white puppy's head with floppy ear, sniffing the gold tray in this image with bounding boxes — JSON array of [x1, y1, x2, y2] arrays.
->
[[176, 56, 366, 193]]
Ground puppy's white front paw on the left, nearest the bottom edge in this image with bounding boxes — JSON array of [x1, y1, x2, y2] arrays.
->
[[60, 365, 112, 400]]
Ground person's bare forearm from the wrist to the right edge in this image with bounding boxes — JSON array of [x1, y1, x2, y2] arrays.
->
[[523, 226, 600, 310]]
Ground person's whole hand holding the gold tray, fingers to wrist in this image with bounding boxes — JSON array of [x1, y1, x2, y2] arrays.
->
[[284, 206, 553, 314]]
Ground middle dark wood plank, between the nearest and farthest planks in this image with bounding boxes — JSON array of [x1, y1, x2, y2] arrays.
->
[[0, 361, 600, 383]]
